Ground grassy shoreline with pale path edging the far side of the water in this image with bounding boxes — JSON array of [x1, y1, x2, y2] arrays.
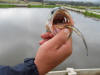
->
[[0, 4, 100, 19]]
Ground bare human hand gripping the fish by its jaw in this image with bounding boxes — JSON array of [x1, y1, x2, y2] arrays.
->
[[34, 29, 72, 75]]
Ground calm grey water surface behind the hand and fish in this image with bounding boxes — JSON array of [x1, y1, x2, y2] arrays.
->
[[0, 8, 100, 70]]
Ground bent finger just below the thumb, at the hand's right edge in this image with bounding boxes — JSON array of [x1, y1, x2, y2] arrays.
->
[[57, 38, 72, 59]]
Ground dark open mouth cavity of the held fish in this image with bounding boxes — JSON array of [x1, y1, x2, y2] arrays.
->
[[53, 13, 69, 28]]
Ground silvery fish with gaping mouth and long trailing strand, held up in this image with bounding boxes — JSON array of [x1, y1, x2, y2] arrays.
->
[[46, 7, 88, 56]]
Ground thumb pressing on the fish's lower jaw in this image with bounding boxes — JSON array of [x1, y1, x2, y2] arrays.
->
[[47, 29, 70, 49]]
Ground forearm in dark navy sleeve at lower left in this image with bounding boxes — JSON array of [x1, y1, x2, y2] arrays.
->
[[0, 59, 39, 75]]
